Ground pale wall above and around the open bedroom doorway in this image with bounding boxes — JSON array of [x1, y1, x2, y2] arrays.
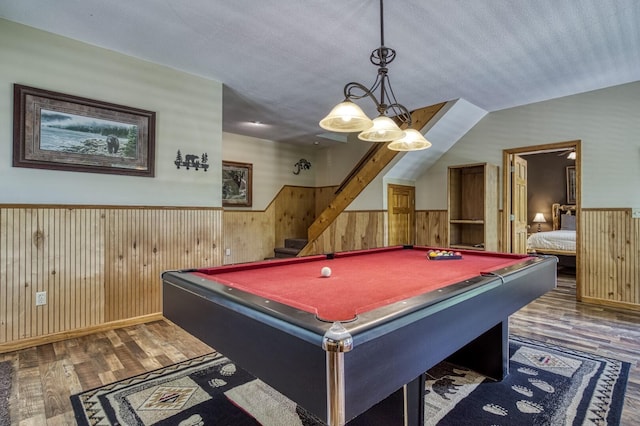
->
[[416, 82, 640, 210]]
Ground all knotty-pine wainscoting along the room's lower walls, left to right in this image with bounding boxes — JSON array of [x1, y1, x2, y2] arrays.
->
[[0, 203, 640, 352]]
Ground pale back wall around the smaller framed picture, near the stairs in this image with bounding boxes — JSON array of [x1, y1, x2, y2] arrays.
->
[[222, 133, 321, 210]]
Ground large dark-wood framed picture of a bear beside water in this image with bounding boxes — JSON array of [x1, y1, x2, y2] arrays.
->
[[13, 84, 156, 177]]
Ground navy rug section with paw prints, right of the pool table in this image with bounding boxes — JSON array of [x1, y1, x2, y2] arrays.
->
[[425, 336, 630, 425]]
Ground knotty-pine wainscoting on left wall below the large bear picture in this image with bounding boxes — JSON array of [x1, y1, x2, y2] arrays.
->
[[0, 206, 223, 352]]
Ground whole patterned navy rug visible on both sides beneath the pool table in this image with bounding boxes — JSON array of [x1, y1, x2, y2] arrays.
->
[[71, 336, 629, 426]]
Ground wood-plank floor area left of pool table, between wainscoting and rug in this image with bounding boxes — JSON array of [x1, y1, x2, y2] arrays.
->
[[0, 321, 212, 426]]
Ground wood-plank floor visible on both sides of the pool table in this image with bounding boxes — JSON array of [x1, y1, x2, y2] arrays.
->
[[0, 276, 640, 426]]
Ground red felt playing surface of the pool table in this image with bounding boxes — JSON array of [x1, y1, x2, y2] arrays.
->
[[194, 247, 527, 321]]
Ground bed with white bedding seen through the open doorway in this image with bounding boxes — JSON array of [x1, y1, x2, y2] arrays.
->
[[527, 203, 576, 267]]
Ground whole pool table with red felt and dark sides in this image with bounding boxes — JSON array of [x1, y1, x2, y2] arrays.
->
[[162, 246, 557, 425]]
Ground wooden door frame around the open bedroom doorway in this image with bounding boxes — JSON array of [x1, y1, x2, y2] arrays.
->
[[502, 139, 582, 300]]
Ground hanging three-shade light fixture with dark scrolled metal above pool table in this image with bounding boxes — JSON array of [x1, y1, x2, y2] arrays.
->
[[320, 0, 431, 151]]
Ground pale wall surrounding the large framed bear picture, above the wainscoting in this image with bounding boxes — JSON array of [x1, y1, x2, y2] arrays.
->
[[0, 19, 222, 207]]
